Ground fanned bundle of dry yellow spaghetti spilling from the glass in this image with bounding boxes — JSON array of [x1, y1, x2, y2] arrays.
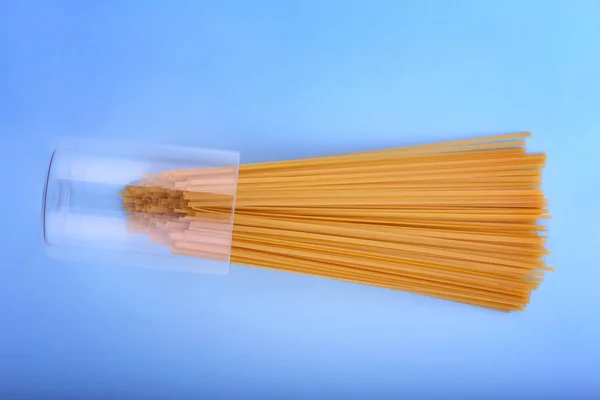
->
[[123, 133, 551, 311]]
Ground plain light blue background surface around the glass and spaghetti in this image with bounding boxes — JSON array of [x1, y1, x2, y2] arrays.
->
[[0, 0, 600, 399]]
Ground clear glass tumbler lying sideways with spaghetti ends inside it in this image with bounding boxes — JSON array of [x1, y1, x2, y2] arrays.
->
[[42, 139, 239, 274]]
